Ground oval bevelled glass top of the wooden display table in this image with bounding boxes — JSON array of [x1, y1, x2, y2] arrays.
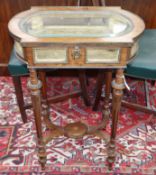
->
[[19, 10, 133, 38]]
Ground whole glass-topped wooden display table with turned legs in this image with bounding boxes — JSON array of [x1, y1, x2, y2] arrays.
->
[[9, 7, 145, 169]]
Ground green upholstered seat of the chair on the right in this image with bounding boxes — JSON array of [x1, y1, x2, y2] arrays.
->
[[126, 29, 156, 80]]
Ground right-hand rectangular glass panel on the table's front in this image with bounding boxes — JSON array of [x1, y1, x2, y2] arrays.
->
[[86, 48, 120, 63]]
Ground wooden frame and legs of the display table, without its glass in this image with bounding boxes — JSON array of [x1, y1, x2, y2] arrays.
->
[[9, 7, 145, 169]]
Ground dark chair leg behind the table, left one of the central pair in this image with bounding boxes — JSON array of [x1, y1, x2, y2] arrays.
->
[[78, 70, 91, 106]]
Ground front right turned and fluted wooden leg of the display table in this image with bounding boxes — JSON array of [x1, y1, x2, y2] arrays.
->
[[108, 69, 124, 169]]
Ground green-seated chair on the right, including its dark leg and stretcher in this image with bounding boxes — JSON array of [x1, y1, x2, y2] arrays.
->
[[93, 29, 156, 114]]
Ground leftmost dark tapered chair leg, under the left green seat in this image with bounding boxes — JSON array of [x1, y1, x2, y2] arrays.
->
[[12, 76, 27, 123]]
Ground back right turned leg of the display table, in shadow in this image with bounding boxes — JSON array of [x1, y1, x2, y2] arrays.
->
[[102, 70, 112, 128]]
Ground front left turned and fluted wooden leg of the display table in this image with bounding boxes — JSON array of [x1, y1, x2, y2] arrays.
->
[[28, 69, 46, 169]]
